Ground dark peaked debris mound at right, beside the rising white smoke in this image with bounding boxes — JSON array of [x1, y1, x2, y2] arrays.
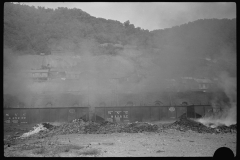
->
[[163, 114, 237, 133]]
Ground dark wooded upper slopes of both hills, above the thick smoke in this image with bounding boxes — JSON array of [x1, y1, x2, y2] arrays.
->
[[4, 3, 236, 78]]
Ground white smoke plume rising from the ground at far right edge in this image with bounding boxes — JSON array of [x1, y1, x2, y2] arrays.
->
[[194, 38, 237, 127]]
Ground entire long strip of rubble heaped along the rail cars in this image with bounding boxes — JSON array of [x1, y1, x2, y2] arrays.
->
[[5, 114, 237, 144]]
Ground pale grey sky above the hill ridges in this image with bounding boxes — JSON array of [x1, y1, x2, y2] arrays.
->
[[21, 2, 236, 31]]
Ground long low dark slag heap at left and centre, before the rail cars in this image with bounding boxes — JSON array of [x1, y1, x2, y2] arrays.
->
[[19, 119, 158, 137]]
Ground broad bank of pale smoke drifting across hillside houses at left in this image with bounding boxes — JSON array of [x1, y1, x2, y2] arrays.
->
[[4, 39, 171, 107]]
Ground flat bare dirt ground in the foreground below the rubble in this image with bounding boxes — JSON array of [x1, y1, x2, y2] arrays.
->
[[4, 122, 237, 157]]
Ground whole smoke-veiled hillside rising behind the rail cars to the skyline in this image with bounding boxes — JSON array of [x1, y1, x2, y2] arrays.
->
[[4, 3, 236, 107]]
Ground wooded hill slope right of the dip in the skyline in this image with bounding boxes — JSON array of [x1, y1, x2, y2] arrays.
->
[[151, 19, 236, 57]]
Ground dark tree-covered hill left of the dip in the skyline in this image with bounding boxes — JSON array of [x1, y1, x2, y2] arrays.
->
[[4, 3, 150, 53]]
